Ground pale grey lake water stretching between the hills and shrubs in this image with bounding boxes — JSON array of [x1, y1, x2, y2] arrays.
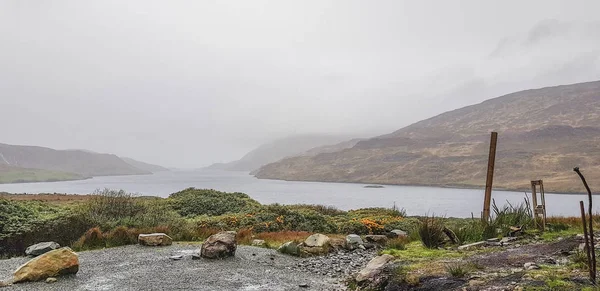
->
[[0, 170, 600, 217]]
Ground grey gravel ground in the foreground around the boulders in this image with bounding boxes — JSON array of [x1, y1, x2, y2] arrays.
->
[[0, 244, 345, 291]]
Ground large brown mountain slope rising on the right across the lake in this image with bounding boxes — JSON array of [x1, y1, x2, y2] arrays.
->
[[256, 81, 600, 192]]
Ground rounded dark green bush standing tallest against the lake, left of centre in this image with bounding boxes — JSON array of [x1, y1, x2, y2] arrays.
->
[[169, 188, 261, 216]]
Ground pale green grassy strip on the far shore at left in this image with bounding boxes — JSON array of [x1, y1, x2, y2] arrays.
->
[[0, 166, 84, 184]]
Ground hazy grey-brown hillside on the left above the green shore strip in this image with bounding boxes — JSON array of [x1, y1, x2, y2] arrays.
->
[[0, 144, 150, 177]]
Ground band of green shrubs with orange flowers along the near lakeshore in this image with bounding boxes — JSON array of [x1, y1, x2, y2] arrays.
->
[[0, 188, 418, 255]]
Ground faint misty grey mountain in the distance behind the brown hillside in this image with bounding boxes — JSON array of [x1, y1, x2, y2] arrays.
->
[[208, 134, 358, 171]]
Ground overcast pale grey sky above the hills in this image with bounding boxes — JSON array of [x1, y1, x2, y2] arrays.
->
[[0, 0, 600, 168]]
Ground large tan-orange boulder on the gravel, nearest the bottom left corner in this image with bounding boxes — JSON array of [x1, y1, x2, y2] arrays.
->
[[13, 247, 79, 283]]
